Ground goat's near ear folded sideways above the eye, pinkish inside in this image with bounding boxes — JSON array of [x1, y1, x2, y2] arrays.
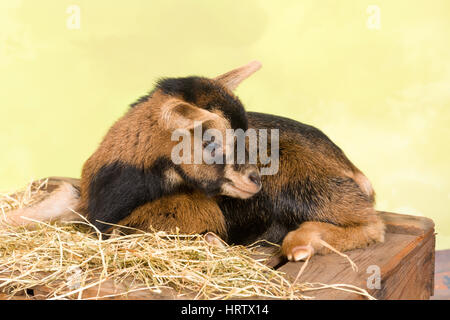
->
[[160, 98, 219, 130]]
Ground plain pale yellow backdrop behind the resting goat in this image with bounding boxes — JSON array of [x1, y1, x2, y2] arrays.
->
[[0, 0, 450, 249]]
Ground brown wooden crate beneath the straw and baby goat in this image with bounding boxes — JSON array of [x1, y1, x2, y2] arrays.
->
[[0, 178, 435, 299]]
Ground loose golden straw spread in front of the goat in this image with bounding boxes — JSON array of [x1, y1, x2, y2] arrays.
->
[[0, 181, 371, 299]]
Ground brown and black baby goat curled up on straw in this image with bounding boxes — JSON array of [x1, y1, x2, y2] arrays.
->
[[1, 62, 384, 261]]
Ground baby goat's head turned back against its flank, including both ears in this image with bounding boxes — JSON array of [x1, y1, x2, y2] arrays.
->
[[148, 62, 261, 199]]
